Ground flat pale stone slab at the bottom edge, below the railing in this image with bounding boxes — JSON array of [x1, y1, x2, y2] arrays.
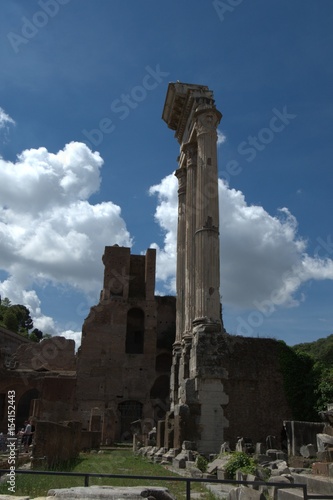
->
[[48, 486, 175, 500]]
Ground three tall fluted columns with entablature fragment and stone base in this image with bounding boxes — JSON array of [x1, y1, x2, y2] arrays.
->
[[162, 82, 228, 453]]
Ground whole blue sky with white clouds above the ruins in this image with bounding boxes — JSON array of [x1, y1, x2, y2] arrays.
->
[[0, 0, 333, 345]]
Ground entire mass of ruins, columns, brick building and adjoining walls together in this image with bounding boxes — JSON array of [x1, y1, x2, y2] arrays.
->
[[0, 82, 292, 455]]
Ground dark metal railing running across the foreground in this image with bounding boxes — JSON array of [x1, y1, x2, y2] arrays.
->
[[0, 469, 333, 500]]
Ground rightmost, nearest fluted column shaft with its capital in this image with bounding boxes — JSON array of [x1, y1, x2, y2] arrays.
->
[[194, 103, 222, 325]]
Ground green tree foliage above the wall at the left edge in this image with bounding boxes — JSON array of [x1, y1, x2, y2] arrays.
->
[[0, 297, 48, 342]]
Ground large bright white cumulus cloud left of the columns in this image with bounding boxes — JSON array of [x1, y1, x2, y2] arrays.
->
[[0, 142, 132, 338]]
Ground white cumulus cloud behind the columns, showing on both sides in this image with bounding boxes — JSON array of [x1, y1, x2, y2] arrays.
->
[[150, 175, 333, 309]]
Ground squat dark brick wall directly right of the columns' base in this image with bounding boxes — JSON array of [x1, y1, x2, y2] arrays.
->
[[222, 335, 292, 446]]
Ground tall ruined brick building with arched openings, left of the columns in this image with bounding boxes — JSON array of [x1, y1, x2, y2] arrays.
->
[[72, 246, 175, 442]]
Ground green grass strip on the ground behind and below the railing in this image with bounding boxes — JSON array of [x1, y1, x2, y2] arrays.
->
[[0, 449, 215, 500]]
